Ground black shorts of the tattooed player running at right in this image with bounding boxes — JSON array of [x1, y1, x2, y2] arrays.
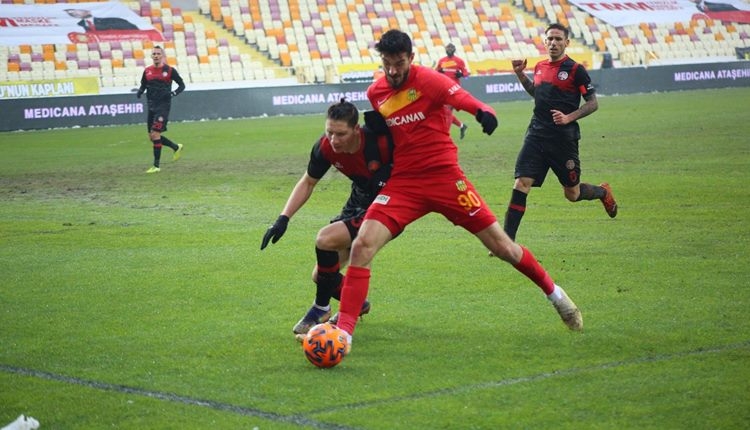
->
[[515, 122, 581, 187]]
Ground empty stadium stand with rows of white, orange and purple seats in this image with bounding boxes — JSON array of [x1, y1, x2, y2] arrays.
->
[[0, 0, 750, 89]]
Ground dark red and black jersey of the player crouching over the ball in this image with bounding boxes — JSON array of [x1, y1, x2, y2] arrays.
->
[[307, 127, 393, 212]]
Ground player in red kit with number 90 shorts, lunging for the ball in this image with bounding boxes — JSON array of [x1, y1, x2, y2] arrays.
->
[[338, 30, 583, 354]]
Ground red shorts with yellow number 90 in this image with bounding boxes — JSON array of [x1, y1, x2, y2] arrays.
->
[[365, 170, 497, 236]]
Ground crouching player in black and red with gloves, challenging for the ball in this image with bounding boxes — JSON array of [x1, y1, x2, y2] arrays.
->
[[260, 99, 393, 341]]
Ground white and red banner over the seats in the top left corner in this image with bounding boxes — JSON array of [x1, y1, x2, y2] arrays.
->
[[0, 2, 164, 45]]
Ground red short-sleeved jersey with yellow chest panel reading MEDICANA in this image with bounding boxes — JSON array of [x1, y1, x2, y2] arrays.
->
[[367, 65, 495, 177]]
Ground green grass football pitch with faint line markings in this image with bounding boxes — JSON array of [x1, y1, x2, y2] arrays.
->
[[0, 88, 750, 429]]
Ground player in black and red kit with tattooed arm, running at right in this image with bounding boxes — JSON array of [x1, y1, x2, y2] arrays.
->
[[504, 23, 617, 240]]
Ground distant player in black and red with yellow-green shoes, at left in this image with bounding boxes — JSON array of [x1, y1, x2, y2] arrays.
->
[[136, 46, 185, 173]]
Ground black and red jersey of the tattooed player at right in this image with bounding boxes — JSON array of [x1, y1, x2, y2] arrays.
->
[[533, 55, 595, 132]]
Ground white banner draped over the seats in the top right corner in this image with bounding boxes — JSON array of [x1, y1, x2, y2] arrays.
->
[[570, 0, 750, 27]]
